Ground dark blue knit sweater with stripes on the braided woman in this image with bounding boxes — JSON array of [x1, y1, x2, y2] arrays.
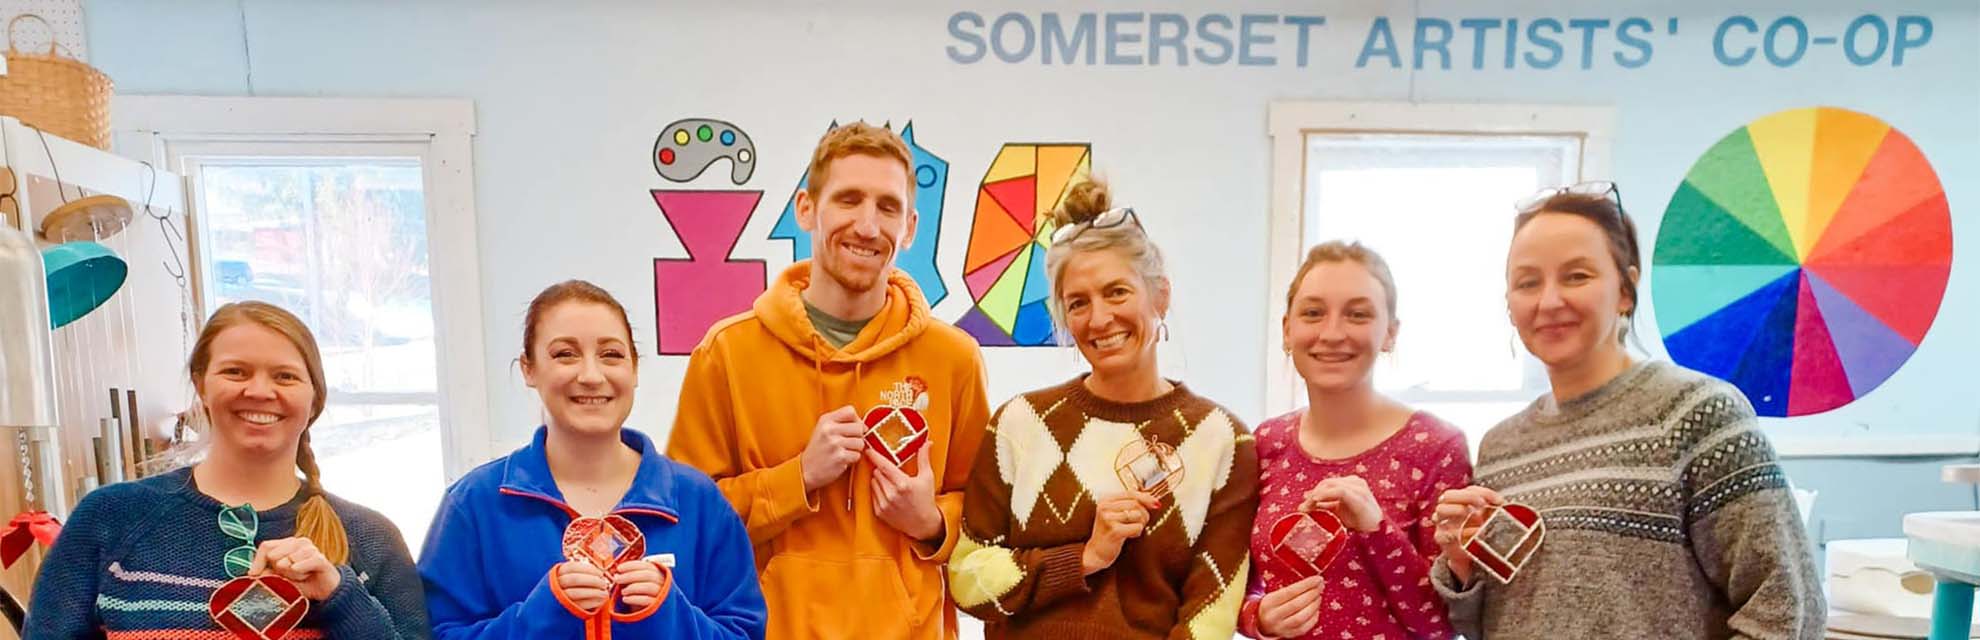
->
[[26, 468, 430, 640]]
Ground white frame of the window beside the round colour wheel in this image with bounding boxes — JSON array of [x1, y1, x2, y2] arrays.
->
[[1259, 101, 1616, 416]]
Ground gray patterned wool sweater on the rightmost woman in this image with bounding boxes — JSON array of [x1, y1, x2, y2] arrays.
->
[[1432, 363, 1828, 640]]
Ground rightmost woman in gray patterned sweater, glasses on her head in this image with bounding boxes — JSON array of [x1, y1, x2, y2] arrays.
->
[[1432, 182, 1828, 640]]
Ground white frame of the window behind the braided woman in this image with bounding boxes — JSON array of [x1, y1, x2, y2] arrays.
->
[[111, 95, 495, 475]]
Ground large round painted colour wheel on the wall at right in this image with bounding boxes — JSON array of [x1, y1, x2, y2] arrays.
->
[[1651, 107, 1952, 416]]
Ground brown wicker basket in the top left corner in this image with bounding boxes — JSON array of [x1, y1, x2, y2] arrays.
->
[[0, 14, 111, 151]]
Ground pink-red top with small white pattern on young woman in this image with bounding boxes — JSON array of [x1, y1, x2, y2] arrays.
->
[[1238, 408, 1471, 640]]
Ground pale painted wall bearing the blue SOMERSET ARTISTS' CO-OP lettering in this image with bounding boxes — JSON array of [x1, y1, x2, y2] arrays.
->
[[87, 0, 1980, 465]]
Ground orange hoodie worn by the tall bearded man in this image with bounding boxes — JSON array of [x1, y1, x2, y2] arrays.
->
[[667, 262, 990, 638]]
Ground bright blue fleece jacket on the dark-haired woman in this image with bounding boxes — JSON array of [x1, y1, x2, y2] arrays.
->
[[420, 426, 766, 640]]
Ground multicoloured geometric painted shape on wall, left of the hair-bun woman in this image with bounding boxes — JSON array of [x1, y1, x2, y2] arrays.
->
[[956, 145, 1093, 347]]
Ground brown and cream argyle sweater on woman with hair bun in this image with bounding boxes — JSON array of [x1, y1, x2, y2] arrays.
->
[[948, 376, 1257, 640]]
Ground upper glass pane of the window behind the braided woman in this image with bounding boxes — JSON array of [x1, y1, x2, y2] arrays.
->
[[200, 160, 436, 392]]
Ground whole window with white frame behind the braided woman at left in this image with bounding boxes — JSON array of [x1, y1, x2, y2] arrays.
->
[[117, 97, 489, 549]]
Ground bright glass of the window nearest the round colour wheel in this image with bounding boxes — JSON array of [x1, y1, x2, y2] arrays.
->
[[1305, 135, 1580, 392]]
